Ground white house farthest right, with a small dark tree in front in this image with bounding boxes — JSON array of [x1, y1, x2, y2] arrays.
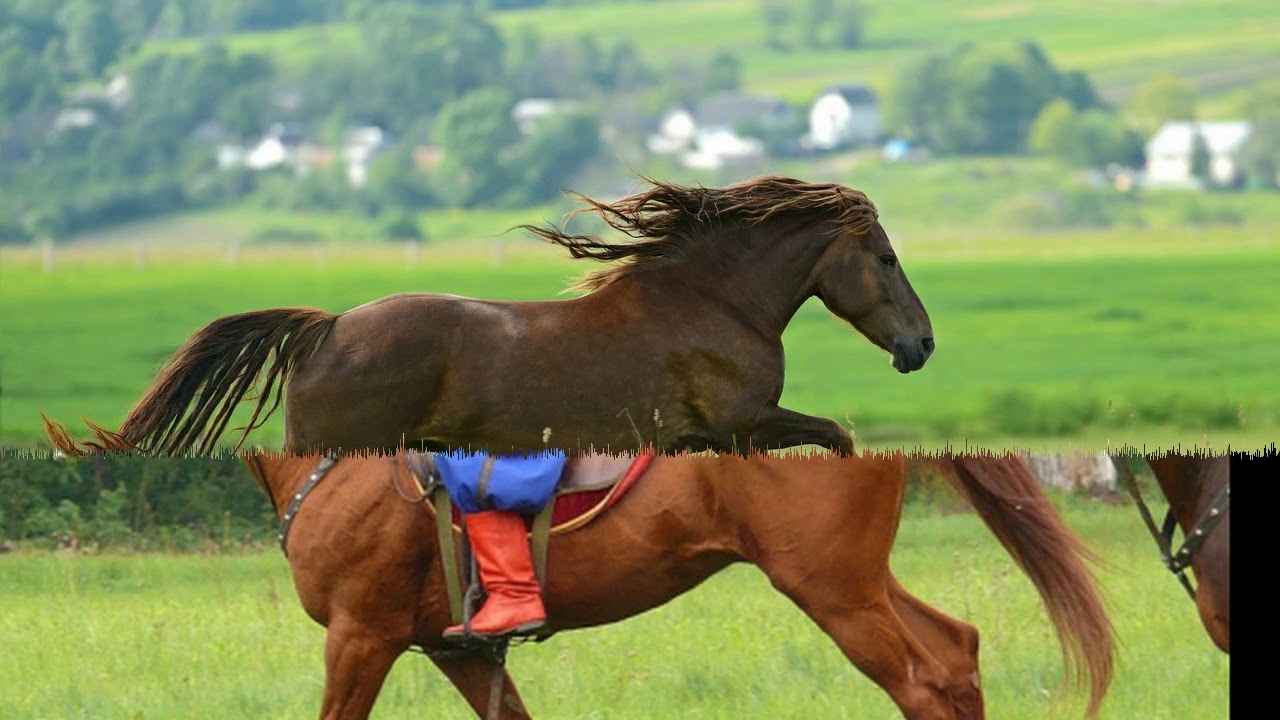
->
[[1146, 120, 1252, 188]]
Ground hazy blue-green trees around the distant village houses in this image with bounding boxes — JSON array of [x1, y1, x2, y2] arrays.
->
[[0, 0, 1280, 242]]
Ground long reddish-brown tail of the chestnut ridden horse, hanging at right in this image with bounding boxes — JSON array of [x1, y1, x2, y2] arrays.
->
[[942, 455, 1115, 717]]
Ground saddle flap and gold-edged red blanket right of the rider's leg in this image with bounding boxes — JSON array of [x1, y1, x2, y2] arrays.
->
[[410, 452, 654, 534]]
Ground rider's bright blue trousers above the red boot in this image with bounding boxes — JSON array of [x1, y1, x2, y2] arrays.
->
[[435, 451, 568, 515]]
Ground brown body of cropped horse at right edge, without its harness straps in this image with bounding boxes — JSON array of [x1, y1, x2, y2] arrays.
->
[[1131, 452, 1231, 653]]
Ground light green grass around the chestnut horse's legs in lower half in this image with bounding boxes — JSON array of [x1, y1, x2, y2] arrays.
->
[[0, 498, 1230, 720]]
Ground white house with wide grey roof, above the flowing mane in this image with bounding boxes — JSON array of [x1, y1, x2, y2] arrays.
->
[[646, 92, 795, 170]]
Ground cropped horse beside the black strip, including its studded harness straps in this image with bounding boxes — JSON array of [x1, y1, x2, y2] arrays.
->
[[1116, 452, 1231, 653]]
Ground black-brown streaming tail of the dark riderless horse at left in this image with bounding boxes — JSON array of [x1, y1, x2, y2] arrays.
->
[[45, 307, 338, 455]]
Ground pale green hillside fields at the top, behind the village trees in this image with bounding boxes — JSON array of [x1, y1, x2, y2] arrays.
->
[[132, 0, 1280, 111]]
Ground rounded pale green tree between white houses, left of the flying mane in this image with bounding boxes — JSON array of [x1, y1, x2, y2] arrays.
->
[[435, 87, 518, 206]]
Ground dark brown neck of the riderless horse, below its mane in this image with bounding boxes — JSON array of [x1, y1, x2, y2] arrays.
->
[[645, 215, 833, 334]]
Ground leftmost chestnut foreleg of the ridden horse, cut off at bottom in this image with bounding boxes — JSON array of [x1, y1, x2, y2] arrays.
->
[[320, 609, 408, 720]]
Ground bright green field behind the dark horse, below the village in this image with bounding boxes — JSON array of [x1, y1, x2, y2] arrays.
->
[[0, 227, 1280, 448]]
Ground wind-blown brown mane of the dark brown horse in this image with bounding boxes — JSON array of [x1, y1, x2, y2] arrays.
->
[[518, 176, 878, 291]]
